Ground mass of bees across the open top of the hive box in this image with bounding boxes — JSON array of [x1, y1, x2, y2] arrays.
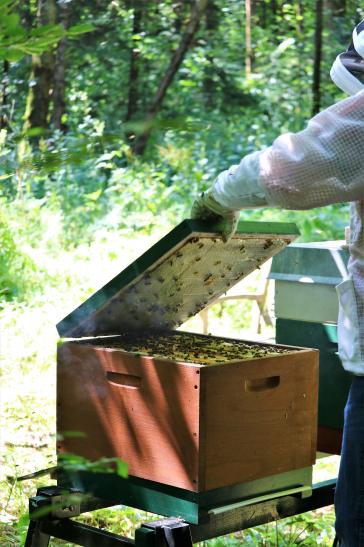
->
[[94, 331, 290, 365]]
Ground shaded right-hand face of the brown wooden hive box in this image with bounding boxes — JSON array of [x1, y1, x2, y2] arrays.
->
[[200, 350, 318, 490]]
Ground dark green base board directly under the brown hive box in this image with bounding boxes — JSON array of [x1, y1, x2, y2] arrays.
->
[[58, 467, 312, 524]]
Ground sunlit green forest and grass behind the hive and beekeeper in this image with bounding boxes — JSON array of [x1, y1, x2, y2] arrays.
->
[[0, 0, 364, 545]]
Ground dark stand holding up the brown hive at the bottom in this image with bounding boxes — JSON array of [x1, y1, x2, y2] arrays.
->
[[25, 479, 336, 547]]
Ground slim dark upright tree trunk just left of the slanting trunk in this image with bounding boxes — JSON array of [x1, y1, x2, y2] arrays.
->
[[125, 0, 143, 121]]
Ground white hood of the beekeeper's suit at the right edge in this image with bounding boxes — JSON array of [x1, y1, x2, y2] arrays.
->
[[330, 20, 364, 95]]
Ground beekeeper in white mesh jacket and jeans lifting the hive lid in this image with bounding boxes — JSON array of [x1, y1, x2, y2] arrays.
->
[[192, 20, 364, 547]]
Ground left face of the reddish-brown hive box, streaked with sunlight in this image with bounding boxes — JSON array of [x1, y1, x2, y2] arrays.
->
[[57, 343, 200, 490]]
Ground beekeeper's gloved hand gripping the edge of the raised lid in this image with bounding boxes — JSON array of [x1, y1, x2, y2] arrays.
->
[[191, 188, 239, 241]]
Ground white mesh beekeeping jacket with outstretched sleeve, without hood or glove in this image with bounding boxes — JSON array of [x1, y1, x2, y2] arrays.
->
[[212, 91, 364, 375]]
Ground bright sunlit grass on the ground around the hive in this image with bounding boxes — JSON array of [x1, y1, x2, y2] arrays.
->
[[0, 225, 337, 547]]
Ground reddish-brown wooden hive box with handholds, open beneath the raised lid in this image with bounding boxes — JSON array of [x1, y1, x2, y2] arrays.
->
[[57, 333, 318, 491]]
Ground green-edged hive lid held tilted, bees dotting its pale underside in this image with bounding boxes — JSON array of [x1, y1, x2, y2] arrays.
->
[[57, 220, 299, 338]]
